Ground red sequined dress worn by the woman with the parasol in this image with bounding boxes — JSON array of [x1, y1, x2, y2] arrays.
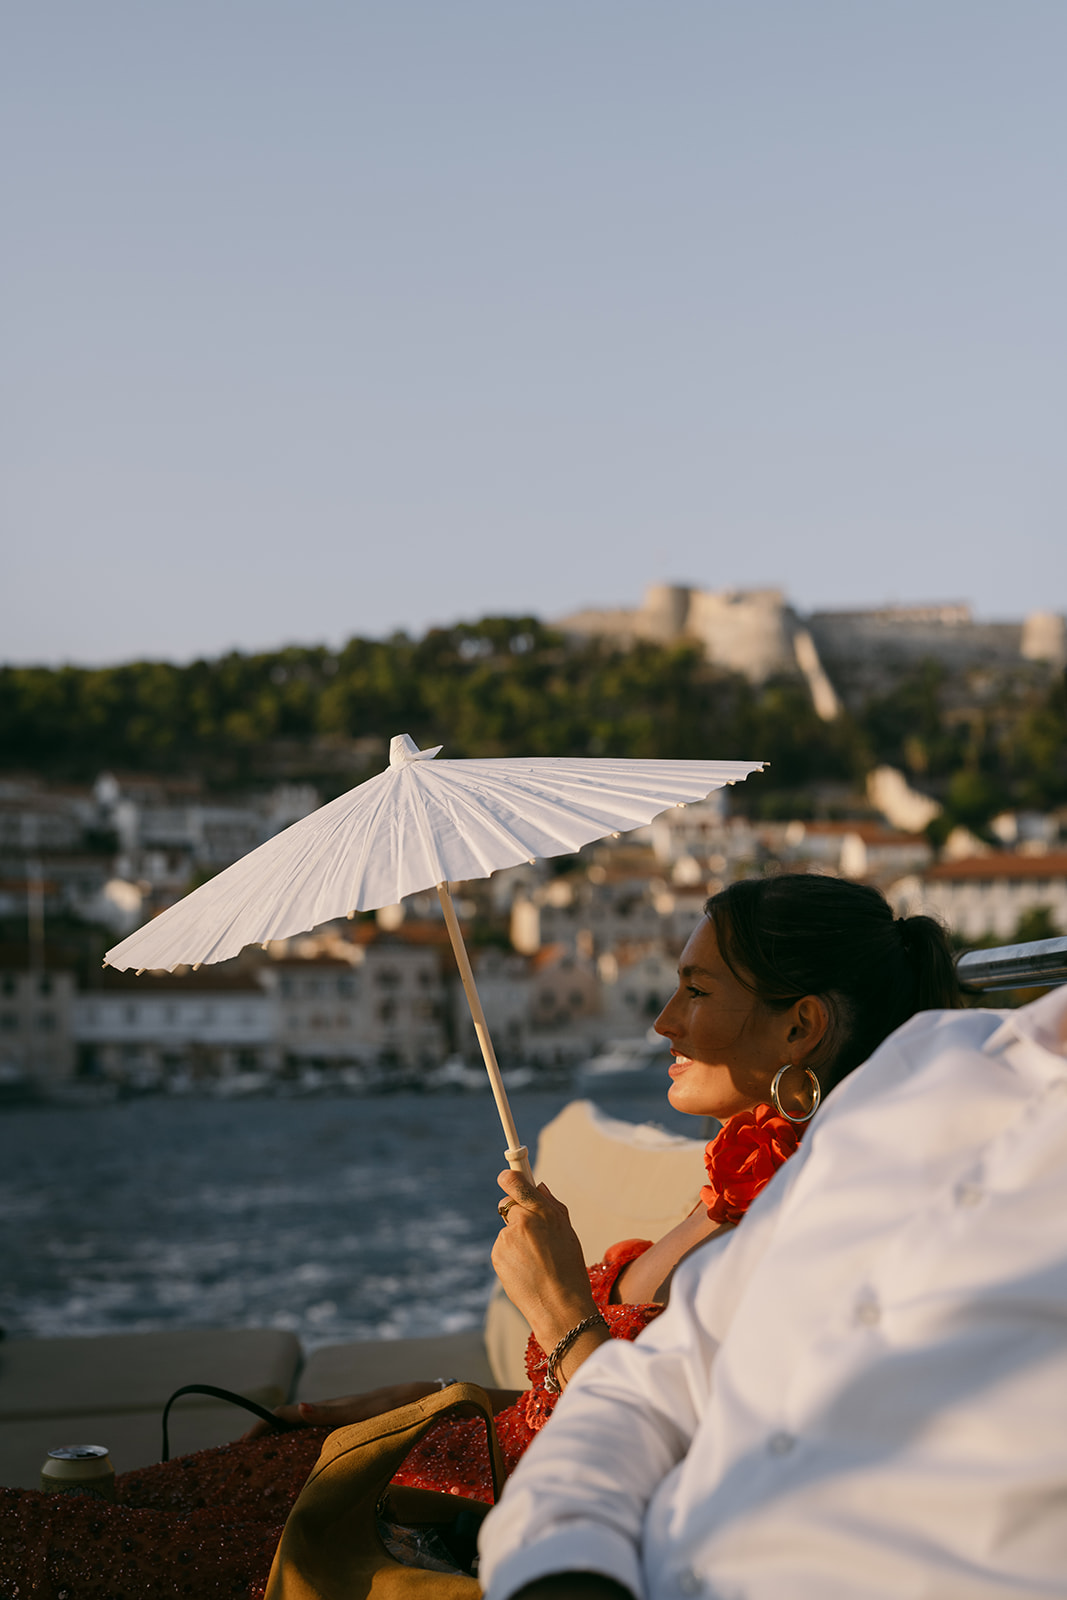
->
[[0, 1240, 662, 1600]]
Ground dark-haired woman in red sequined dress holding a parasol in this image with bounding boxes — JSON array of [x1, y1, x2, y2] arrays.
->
[[0, 875, 960, 1600]]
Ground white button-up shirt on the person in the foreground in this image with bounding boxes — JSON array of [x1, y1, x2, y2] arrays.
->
[[482, 989, 1067, 1600]]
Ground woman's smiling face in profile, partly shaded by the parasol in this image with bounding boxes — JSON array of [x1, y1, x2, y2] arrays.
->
[[656, 917, 790, 1122]]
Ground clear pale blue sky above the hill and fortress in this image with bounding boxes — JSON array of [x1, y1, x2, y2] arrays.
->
[[0, 0, 1067, 662]]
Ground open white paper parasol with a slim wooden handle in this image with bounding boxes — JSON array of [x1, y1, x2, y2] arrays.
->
[[104, 733, 763, 1171]]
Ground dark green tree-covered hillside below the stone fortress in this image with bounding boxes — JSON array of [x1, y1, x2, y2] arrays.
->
[[0, 616, 1067, 829]]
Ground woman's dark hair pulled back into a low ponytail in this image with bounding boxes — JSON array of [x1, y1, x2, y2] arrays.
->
[[704, 872, 961, 1090]]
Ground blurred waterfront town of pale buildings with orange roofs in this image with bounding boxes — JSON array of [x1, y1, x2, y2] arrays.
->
[[0, 755, 1067, 1098]]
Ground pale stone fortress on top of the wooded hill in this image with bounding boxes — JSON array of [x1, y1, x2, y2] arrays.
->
[[557, 584, 1067, 722]]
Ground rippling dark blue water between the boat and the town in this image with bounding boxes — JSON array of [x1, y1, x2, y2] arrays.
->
[[0, 1090, 699, 1346]]
